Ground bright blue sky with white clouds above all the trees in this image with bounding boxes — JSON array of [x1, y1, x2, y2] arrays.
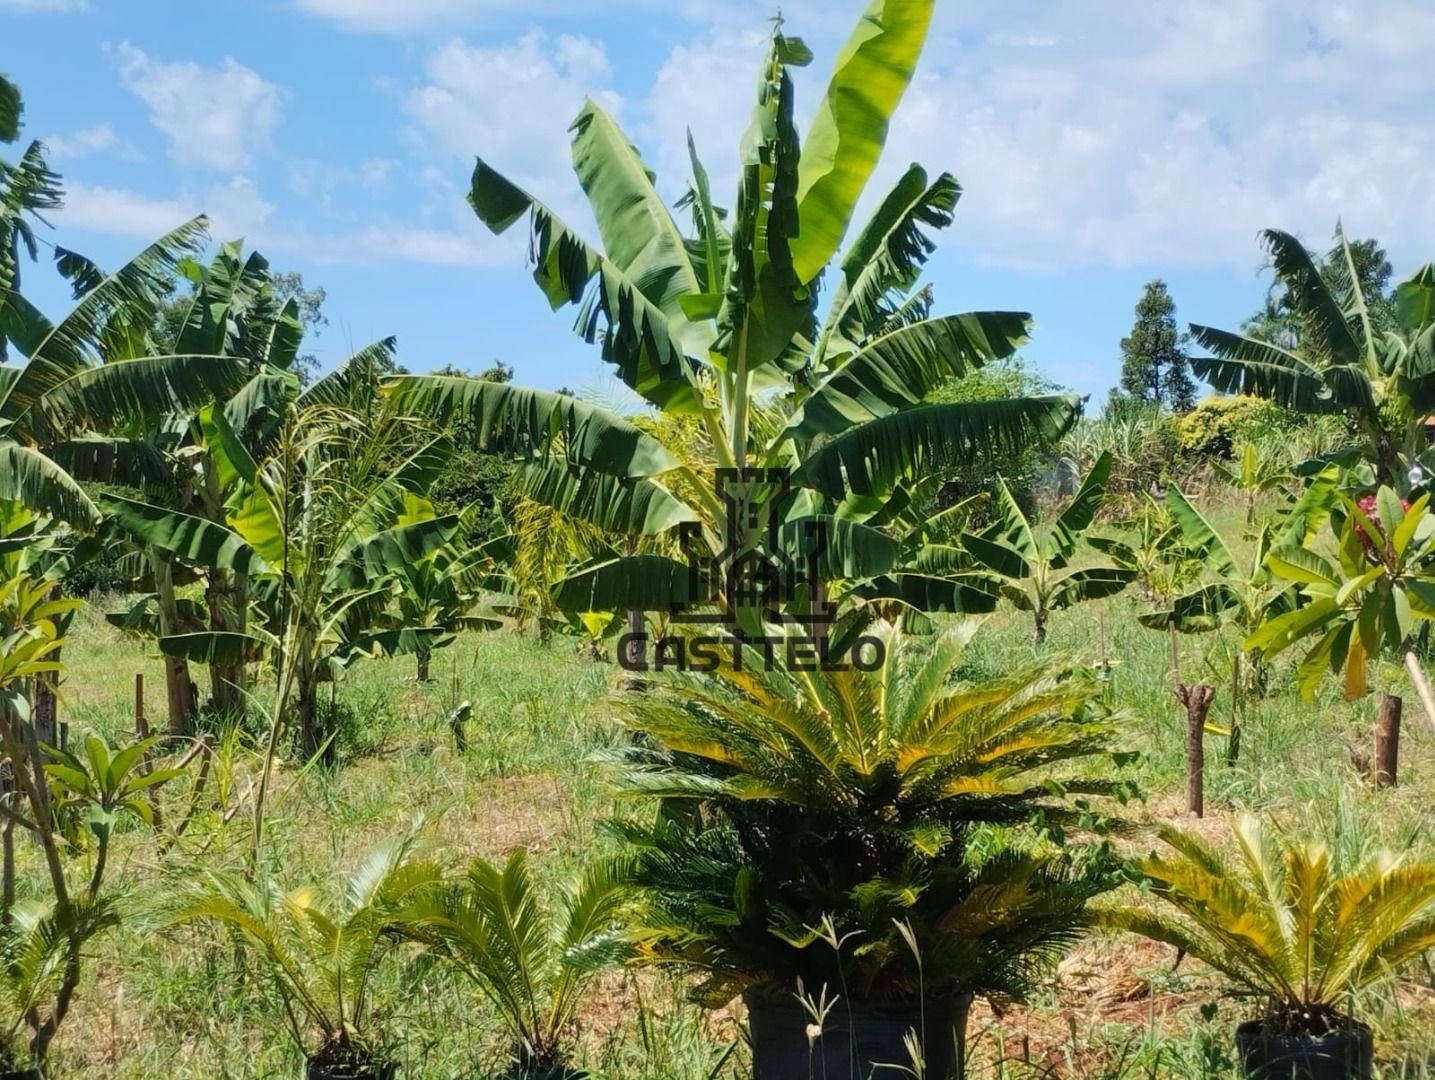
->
[[0, 0, 1435, 400]]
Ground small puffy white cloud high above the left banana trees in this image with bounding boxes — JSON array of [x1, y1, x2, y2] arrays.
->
[[113, 42, 284, 172]]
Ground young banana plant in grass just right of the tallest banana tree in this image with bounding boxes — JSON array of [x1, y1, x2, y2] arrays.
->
[[961, 453, 1137, 645]]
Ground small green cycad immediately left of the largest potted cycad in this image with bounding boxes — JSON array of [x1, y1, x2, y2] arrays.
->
[[405, 848, 631, 1080]]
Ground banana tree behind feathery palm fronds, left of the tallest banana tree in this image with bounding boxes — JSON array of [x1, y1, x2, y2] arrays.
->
[[103, 350, 458, 753]]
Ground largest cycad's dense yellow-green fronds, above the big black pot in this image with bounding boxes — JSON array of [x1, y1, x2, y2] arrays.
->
[[614, 622, 1126, 1004]]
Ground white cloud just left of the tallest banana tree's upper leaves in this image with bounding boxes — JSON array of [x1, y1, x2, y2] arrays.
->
[[403, 30, 623, 219]]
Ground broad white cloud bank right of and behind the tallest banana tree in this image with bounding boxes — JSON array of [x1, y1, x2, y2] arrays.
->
[[645, 0, 1435, 271]]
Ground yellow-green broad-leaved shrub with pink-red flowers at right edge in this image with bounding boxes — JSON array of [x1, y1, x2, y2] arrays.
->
[[1246, 486, 1435, 729]]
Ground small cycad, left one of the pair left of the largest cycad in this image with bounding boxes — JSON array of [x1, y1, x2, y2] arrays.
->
[[175, 829, 442, 1079]]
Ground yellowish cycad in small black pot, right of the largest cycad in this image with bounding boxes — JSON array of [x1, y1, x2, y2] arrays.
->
[[1102, 815, 1435, 1037]]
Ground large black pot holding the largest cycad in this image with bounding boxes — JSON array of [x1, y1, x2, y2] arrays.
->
[[743, 990, 971, 1080]]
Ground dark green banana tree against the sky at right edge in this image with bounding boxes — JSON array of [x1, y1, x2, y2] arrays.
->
[[1191, 228, 1435, 492]]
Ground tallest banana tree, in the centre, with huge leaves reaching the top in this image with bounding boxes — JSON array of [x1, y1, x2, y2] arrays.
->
[[390, 0, 1078, 631]]
